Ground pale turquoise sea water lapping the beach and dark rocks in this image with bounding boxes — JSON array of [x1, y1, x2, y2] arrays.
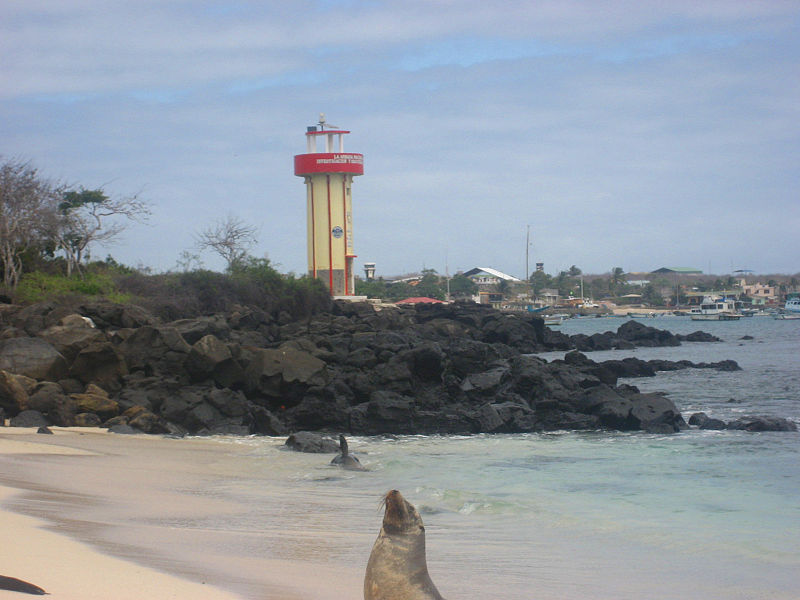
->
[[191, 317, 800, 600]]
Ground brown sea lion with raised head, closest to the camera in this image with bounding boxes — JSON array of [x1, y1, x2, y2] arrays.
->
[[364, 490, 444, 600]]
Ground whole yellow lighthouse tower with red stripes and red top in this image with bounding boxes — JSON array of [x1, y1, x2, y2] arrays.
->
[[294, 114, 364, 296]]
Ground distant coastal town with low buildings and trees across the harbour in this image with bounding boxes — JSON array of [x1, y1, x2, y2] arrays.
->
[[356, 263, 800, 316]]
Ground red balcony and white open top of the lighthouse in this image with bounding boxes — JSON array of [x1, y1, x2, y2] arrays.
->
[[294, 114, 364, 177]]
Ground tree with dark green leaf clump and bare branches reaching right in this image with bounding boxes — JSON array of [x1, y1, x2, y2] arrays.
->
[[51, 188, 150, 276]]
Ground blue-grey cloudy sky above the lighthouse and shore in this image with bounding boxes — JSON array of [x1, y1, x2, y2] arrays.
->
[[0, 0, 800, 277]]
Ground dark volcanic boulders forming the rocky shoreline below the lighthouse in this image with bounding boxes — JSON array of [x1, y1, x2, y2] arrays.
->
[[0, 302, 796, 435]]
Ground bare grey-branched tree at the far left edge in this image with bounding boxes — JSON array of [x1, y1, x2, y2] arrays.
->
[[0, 160, 60, 289]]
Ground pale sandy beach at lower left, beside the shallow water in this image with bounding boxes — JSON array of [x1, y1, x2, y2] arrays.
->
[[0, 428, 368, 600]]
